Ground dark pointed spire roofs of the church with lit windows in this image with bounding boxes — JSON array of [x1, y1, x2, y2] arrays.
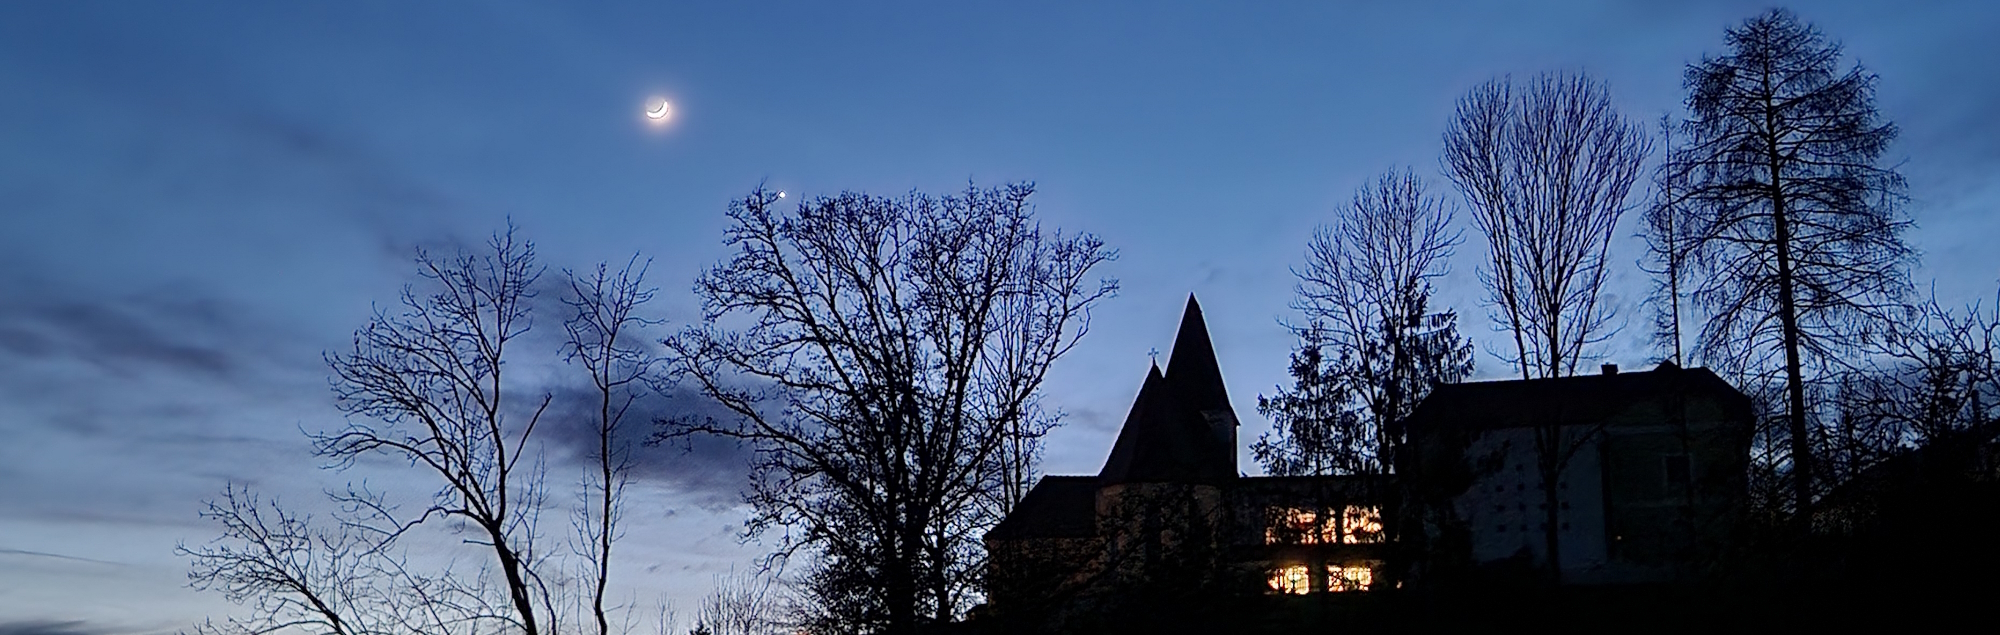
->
[[1098, 296, 1236, 483]]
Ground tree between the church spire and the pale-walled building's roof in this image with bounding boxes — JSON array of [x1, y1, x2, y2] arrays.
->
[[1252, 170, 1472, 473]]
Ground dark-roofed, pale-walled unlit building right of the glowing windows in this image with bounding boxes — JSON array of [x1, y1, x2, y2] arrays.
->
[[1406, 363, 1754, 585]]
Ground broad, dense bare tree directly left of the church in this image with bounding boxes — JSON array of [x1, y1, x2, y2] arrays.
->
[[666, 184, 1116, 633]]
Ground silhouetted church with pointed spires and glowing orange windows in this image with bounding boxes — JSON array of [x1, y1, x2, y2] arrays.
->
[[984, 296, 1392, 621]]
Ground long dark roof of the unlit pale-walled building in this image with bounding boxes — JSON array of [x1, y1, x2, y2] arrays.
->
[[1408, 363, 1750, 433]]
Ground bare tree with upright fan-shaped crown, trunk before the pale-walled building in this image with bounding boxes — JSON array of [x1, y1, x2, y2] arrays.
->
[[1444, 74, 1652, 581]]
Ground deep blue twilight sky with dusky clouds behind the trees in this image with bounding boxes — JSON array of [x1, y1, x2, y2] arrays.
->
[[0, 2, 2000, 635]]
